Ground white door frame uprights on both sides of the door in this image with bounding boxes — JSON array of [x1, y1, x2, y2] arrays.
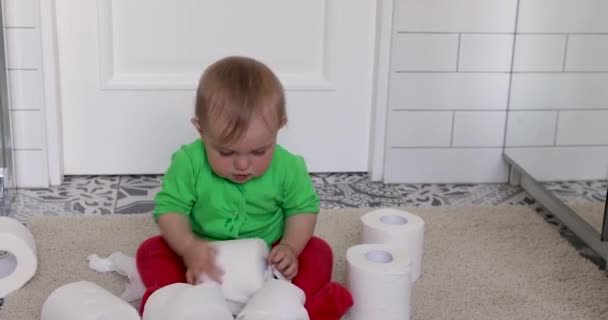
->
[[40, 0, 394, 185]]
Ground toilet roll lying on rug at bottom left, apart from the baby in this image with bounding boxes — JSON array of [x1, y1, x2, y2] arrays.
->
[[40, 281, 141, 320]]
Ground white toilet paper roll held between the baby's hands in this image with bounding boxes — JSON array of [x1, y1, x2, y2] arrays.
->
[[212, 239, 268, 315]]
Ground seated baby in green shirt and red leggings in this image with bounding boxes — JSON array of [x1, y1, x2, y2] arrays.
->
[[137, 57, 353, 320]]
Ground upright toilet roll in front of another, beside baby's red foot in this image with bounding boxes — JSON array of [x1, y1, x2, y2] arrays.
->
[[346, 244, 412, 320]]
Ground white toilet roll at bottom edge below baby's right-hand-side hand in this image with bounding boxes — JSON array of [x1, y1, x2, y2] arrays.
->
[[236, 279, 309, 320]]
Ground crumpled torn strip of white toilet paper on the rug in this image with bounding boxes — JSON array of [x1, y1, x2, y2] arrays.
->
[[87, 251, 146, 302]]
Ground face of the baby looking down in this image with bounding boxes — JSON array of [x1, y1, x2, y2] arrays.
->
[[201, 117, 278, 183]]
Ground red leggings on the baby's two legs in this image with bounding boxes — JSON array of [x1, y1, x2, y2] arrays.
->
[[137, 236, 353, 320]]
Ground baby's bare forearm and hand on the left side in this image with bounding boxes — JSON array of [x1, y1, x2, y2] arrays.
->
[[158, 213, 222, 284]]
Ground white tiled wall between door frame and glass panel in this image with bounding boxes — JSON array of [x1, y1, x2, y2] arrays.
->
[[384, 0, 517, 183]]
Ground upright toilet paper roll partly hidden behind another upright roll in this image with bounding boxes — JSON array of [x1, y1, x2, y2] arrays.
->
[[361, 209, 424, 282]]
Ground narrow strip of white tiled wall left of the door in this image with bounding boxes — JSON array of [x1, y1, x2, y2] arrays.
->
[[3, 0, 49, 187]]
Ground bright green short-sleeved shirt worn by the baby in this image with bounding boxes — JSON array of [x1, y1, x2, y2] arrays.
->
[[154, 139, 319, 245]]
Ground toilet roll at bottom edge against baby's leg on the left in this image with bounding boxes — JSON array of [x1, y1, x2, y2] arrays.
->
[[142, 281, 234, 320]]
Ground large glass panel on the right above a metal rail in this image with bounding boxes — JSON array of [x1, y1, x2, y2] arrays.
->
[[505, 0, 608, 239]]
